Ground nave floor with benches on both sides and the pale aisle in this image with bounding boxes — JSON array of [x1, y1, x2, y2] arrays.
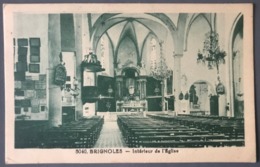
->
[[15, 113, 244, 149]]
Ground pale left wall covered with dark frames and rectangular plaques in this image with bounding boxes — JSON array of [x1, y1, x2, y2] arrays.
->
[[14, 13, 48, 120]]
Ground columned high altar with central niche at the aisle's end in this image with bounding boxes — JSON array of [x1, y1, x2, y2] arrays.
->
[[115, 64, 148, 112]]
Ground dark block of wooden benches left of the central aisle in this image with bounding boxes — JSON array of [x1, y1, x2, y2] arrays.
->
[[15, 116, 104, 148]]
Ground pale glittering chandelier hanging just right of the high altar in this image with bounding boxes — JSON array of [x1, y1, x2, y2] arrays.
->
[[151, 41, 172, 81]]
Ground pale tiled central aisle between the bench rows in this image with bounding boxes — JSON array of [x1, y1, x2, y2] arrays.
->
[[94, 115, 127, 148]]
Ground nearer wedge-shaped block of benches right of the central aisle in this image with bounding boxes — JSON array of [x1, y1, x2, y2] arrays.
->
[[117, 115, 244, 148]]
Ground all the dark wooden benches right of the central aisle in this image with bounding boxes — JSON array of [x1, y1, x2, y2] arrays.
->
[[118, 114, 244, 147]]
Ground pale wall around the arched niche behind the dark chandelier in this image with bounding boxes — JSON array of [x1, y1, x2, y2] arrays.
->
[[181, 16, 225, 115]]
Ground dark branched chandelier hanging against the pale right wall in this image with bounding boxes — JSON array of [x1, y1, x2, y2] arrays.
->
[[197, 31, 226, 73]]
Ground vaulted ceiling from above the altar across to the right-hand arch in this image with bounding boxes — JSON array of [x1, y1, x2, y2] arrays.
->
[[89, 13, 215, 52]]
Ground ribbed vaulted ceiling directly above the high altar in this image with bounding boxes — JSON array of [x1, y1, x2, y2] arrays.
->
[[91, 14, 176, 51]]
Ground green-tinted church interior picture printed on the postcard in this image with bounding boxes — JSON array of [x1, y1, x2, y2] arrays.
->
[[12, 13, 244, 149]]
